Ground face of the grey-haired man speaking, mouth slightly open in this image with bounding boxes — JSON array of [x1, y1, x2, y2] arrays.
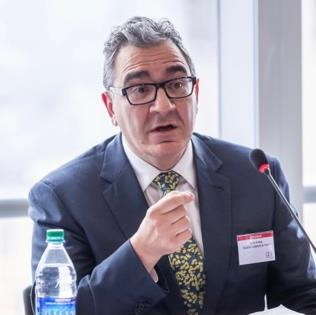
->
[[103, 41, 198, 170]]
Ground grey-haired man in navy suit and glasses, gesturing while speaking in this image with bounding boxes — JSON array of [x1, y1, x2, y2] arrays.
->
[[29, 17, 316, 315]]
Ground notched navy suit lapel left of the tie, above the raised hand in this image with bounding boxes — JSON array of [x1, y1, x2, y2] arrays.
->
[[101, 135, 148, 239]]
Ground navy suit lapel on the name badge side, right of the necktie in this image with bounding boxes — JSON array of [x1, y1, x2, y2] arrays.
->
[[192, 136, 231, 314]]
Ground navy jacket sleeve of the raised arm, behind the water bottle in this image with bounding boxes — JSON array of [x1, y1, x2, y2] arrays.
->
[[29, 181, 165, 315]]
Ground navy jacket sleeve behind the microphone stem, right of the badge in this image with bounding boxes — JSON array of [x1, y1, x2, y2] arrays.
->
[[267, 160, 316, 314]]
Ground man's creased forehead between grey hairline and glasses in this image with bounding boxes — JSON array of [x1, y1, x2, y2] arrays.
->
[[114, 40, 190, 86]]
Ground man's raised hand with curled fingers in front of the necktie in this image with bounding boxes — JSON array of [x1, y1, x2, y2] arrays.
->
[[131, 191, 195, 272]]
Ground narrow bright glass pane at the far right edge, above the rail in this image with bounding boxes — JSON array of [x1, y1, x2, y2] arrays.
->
[[302, 0, 316, 186]]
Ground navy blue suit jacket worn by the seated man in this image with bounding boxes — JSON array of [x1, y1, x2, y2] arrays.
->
[[29, 134, 316, 315]]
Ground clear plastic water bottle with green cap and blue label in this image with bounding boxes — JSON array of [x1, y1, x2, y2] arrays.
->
[[35, 229, 77, 315]]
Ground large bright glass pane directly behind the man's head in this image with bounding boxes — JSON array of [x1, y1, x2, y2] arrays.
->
[[0, 0, 218, 198]]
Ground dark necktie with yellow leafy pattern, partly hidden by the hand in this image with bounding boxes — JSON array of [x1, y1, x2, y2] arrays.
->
[[153, 171, 206, 315]]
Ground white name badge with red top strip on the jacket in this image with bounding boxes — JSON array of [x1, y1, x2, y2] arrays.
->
[[237, 231, 275, 266]]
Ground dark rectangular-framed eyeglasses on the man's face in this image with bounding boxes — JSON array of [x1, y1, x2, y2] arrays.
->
[[110, 77, 196, 105]]
